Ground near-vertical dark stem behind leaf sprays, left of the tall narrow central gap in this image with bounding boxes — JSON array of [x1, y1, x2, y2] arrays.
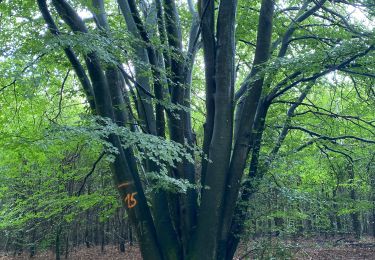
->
[[163, 0, 197, 255]]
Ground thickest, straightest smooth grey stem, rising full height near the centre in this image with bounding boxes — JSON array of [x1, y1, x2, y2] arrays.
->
[[192, 0, 237, 259]]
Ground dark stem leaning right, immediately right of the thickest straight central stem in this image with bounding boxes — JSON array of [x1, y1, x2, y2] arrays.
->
[[220, 0, 274, 257]]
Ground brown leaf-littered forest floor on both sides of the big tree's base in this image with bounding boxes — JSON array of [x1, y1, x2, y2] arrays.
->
[[0, 237, 375, 260]]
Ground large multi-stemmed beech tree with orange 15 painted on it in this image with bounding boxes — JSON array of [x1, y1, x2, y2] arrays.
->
[[5, 0, 374, 260]]
